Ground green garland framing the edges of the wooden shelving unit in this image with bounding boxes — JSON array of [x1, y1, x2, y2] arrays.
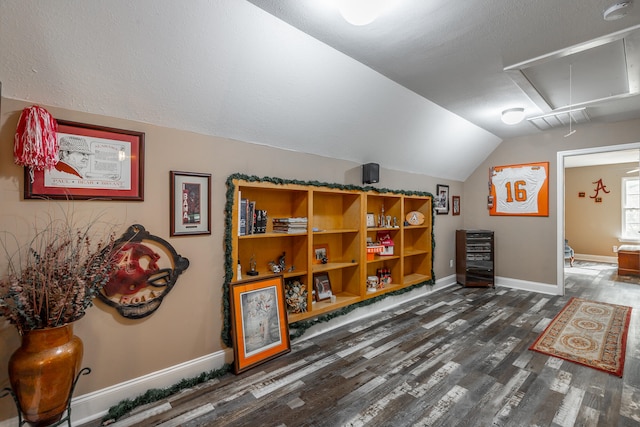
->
[[221, 173, 436, 347]]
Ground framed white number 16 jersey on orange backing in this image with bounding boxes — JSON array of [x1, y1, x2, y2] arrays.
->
[[489, 162, 549, 216]]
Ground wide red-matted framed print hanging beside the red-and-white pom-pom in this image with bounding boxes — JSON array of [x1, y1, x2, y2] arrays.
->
[[24, 120, 144, 201]]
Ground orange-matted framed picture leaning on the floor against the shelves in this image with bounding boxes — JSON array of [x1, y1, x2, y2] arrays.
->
[[230, 275, 291, 374]]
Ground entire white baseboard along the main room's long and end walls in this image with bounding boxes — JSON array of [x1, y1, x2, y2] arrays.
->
[[0, 275, 558, 427]]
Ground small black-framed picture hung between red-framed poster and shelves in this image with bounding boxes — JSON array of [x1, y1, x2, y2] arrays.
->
[[170, 171, 211, 236]]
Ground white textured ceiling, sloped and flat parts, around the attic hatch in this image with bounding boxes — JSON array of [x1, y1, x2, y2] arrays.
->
[[0, 0, 640, 181]]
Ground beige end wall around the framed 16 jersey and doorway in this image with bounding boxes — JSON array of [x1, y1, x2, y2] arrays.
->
[[462, 120, 640, 286]]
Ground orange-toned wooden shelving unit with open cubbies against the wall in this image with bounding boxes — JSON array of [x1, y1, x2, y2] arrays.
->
[[231, 179, 433, 323]]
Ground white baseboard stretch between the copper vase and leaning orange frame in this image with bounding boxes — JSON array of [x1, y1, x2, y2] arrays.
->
[[0, 349, 233, 427]]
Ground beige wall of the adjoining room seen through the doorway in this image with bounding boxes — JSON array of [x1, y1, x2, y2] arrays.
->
[[564, 163, 638, 257]]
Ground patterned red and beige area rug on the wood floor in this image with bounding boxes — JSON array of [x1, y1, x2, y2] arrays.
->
[[529, 298, 631, 377]]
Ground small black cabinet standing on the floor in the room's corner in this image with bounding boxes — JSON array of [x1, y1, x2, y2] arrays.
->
[[456, 230, 495, 287]]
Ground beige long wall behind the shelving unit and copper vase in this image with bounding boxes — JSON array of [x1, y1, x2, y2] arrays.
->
[[0, 99, 464, 420]]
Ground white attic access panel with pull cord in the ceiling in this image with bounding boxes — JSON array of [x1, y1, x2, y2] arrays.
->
[[522, 39, 629, 110]]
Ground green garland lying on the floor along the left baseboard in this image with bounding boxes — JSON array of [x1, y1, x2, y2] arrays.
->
[[102, 364, 231, 425]]
